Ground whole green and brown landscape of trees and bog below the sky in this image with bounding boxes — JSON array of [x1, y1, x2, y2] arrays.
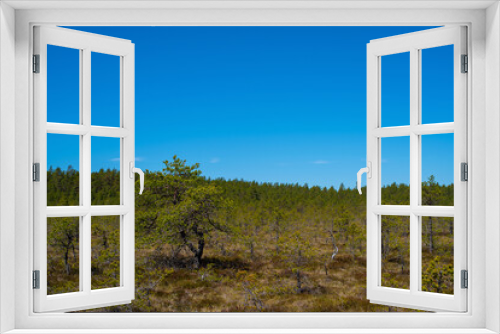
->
[[47, 156, 454, 312]]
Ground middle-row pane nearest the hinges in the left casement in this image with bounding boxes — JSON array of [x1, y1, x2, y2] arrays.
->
[[47, 133, 80, 206]]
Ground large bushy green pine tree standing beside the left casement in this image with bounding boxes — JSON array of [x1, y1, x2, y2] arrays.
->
[[136, 156, 231, 268]]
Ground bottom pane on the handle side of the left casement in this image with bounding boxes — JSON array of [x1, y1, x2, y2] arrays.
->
[[91, 216, 121, 289]]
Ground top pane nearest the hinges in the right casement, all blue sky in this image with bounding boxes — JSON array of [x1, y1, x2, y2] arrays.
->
[[421, 45, 454, 124]]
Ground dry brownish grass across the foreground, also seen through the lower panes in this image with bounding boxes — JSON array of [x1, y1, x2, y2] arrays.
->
[[48, 214, 453, 312]]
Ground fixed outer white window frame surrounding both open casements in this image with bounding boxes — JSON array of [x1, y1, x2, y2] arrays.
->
[[0, 1, 500, 333]]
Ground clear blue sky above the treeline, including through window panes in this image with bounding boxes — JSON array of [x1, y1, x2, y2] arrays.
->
[[48, 27, 453, 187]]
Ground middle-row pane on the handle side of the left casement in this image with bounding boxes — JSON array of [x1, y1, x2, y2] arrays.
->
[[91, 137, 121, 205]]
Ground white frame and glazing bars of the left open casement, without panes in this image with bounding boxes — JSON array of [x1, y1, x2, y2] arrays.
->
[[33, 26, 135, 312]]
